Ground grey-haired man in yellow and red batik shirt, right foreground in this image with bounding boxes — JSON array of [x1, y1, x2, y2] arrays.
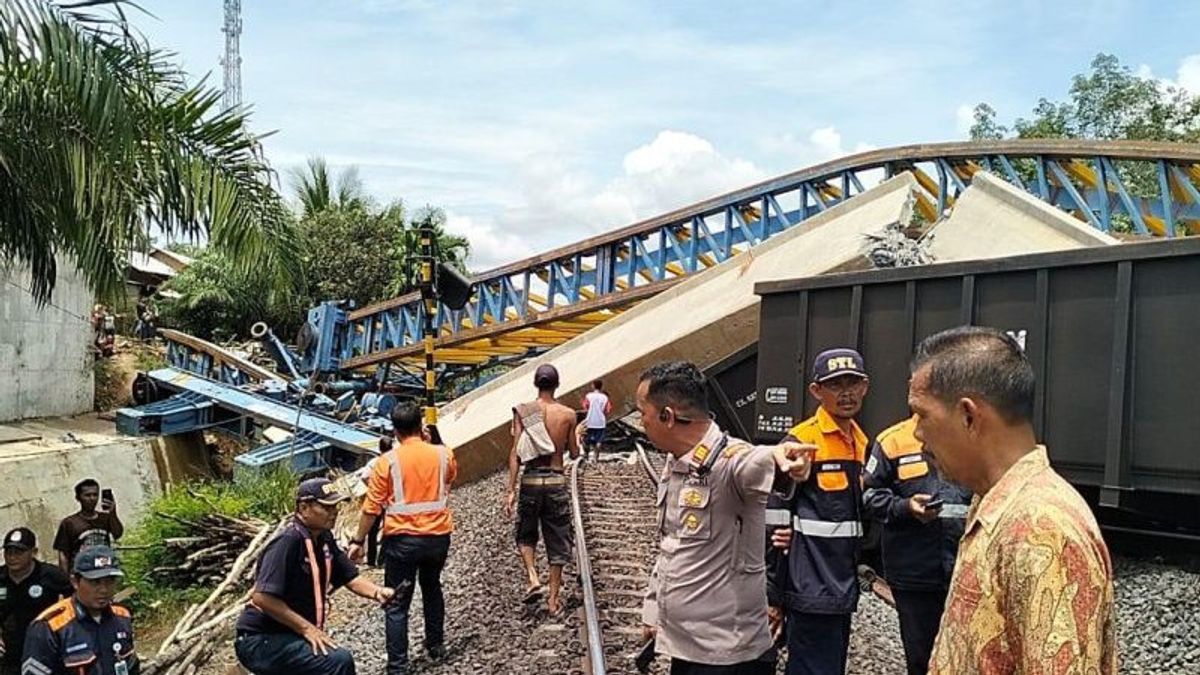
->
[[908, 327, 1117, 675]]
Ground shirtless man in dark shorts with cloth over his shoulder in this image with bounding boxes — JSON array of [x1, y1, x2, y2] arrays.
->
[[504, 364, 580, 616]]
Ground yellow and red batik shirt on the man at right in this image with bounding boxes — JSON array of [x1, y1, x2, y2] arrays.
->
[[929, 446, 1117, 675]]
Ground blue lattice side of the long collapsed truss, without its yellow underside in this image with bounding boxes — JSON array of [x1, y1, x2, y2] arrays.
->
[[331, 141, 1200, 362]]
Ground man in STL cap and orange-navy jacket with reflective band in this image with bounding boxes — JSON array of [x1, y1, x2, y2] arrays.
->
[[767, 348, 869, 675]]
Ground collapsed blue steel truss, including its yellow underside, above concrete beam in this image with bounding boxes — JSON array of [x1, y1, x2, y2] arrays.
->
[[297, 139, 1200, 372]]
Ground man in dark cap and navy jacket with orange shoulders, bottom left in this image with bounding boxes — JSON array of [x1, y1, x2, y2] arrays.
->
[[20, 546, 140, 675]]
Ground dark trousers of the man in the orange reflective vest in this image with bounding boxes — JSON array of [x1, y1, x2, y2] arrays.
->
[[383, 534, 450, 675]]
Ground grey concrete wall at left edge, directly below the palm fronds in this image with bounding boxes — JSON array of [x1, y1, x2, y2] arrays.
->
[[0, 261, 94, 422]]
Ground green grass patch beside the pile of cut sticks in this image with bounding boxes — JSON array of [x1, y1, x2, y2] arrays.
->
[[121, 467, 298, 622]]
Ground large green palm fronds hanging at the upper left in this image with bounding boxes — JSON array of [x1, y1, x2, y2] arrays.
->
[[0, 0, 295, 301]]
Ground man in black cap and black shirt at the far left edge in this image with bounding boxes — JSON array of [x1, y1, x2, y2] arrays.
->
[[0, 527, 71, 675]]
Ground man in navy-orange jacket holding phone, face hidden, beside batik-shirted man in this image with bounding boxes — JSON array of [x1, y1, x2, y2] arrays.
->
[[863, 417, 971, 675]]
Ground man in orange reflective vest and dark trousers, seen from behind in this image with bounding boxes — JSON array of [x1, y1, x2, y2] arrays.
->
[[349, 402, 458, 675]]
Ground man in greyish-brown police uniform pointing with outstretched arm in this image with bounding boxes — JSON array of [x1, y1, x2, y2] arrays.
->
[[637, 362, 808, 675]]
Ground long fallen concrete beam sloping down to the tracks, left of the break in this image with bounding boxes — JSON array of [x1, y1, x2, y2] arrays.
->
[[439, 174, 916, 482]]
